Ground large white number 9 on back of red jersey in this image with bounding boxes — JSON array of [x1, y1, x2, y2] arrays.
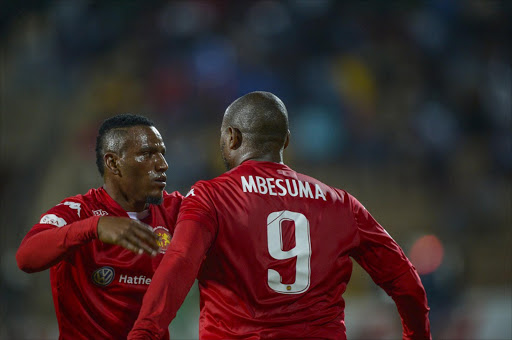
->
[[267, 210, 311, 294]]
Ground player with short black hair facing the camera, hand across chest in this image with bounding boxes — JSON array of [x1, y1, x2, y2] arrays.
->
[[16, 114, 183, 340]]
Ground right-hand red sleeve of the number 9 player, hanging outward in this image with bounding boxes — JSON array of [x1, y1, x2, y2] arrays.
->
[[349, 196, 431, 339]]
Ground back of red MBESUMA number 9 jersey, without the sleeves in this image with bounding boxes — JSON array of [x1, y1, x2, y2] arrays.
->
[[184, 161, 359, 339]]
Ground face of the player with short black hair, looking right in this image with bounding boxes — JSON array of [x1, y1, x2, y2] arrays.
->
[[119, 126, 169, 204]]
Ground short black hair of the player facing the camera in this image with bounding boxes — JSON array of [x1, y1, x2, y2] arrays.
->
[[96, 113, 155, 176]]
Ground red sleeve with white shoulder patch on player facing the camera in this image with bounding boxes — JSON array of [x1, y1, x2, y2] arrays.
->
[[16, 201, 100, 273]]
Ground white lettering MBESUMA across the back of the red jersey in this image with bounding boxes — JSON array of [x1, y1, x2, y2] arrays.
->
[[240, 176, 327, 201]]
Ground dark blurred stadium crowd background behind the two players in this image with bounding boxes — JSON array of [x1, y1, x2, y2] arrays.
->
[[0, 0, 512, 340]]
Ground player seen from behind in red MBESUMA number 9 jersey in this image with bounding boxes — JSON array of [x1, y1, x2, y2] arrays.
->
[[128, 92, 431, 340]]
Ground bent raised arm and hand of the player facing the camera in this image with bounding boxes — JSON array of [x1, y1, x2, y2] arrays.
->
[[16, 215, 158, 273]]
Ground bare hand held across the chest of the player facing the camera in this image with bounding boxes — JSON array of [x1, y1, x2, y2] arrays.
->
[[98, 216, 159, 256]]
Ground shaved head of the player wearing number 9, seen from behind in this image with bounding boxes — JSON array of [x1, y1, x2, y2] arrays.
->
[[221, 91, 289, 169]]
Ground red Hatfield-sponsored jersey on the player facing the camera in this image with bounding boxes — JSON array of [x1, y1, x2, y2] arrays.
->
[[17, 188, 183, 340]]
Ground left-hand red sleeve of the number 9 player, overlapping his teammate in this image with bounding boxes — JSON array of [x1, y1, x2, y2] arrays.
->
[[128, 220, 214, 340]]
